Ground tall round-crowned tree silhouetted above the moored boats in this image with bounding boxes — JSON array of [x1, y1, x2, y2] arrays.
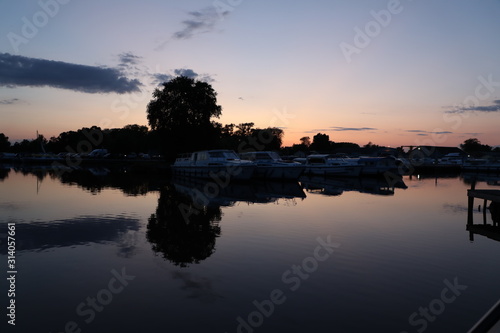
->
[[147, 76, 222, 155]]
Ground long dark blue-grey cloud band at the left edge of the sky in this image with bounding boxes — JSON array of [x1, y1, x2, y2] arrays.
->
[[0, 53, 142, 94]]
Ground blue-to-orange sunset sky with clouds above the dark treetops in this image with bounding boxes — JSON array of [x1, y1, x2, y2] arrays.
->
[[0, 0, 500, 146]]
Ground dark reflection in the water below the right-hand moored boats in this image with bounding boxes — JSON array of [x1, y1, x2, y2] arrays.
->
[[300, 172, 407, 196]]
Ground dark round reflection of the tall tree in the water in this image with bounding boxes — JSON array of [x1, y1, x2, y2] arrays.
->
[[146, 185, 222, 267]]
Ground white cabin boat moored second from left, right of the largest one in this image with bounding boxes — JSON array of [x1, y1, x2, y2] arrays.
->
[[240, 151, 305, 180]]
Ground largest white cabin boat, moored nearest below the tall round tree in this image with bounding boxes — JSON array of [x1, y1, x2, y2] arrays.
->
[[172, 150, 256, 182]]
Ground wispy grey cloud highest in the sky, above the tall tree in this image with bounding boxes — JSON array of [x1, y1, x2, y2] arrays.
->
[[173, 7, 230, 39]]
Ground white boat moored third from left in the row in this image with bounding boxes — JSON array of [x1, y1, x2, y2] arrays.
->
[[304, 154, 362, 177]]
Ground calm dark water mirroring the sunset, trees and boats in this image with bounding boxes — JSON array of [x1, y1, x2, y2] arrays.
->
[[0, 169, 500, 333]]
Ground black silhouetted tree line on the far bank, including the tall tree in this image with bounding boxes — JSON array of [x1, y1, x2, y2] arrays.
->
[[0, 76, 498, 160]]
